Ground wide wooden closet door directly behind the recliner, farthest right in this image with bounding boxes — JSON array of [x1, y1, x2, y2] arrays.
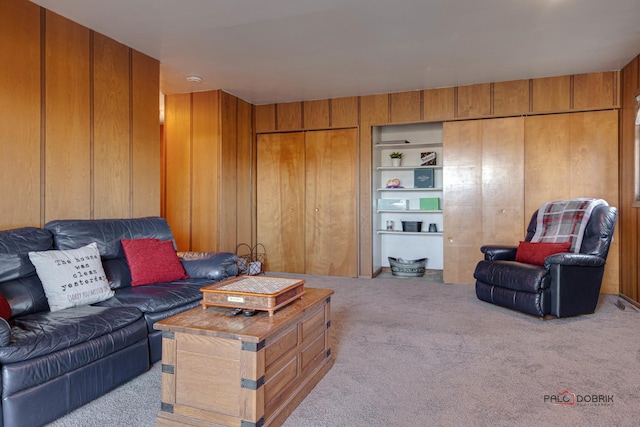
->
[[525, 110, 620, 294]]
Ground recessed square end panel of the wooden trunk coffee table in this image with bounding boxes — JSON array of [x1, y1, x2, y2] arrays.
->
[[175, 335, 241, 417]]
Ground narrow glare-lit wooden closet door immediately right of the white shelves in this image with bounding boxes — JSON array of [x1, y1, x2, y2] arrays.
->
[[442, 120, 483, 283]]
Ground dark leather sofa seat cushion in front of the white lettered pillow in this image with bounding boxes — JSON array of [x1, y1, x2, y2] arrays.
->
[[0, 306, 142, 365]]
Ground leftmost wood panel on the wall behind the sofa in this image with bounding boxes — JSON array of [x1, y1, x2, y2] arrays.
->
[[0, 1, 41, 230]]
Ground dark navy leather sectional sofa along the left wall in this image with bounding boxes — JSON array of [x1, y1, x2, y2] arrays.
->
[[0, 217, 238, 427]]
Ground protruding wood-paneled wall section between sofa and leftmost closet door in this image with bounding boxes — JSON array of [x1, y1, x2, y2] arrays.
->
[[162, 90, 255, 252]]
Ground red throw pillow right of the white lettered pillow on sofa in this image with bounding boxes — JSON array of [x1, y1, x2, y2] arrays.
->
[[122, 239, 189, 286]]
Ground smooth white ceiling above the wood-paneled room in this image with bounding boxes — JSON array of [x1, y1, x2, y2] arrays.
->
[[28, 0, 640, 104]]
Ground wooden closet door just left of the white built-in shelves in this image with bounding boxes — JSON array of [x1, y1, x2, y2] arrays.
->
[[305, 129, 358, 277]]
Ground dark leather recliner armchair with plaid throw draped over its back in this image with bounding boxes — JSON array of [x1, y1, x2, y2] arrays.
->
[[473, 205, 618, 317]]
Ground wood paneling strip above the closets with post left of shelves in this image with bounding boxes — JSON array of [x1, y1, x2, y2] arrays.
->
[[255, 71, 620, 277]]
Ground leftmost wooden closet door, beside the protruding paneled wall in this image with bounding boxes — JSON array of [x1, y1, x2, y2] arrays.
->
[[256, 132, 305, 273]]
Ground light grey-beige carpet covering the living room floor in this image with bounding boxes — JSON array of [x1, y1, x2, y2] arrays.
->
[[51, 276, 640, 427]]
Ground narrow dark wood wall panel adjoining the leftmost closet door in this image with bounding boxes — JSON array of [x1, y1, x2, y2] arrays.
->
[[237, 99, 256, 245]]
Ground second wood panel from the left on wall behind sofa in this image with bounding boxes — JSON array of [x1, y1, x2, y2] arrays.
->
[[44, 11, 92, 222]]
